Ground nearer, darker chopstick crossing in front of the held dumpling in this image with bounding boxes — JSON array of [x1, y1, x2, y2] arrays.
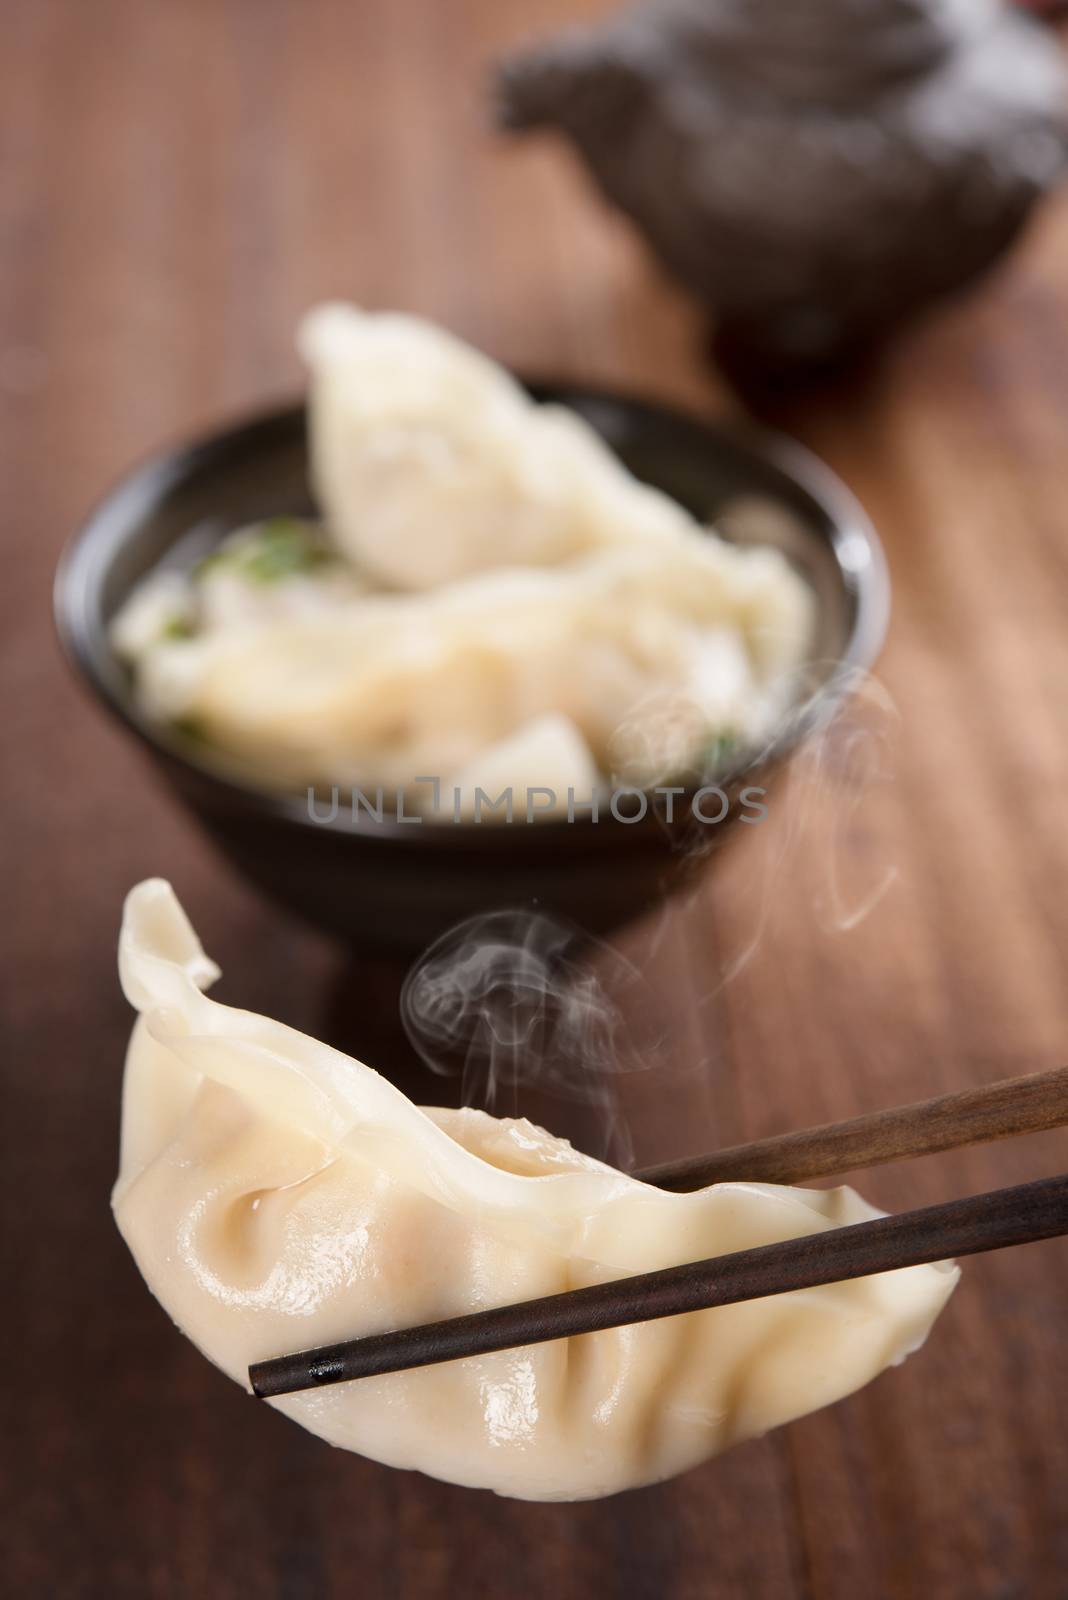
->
[[248, 1173, 1068, 1400]]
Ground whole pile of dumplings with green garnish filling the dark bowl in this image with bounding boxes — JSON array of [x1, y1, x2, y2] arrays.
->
[[112, 306, 814, 803]]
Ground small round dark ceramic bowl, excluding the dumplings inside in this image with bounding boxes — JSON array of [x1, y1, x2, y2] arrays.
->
[[56, 384, 889, 955]]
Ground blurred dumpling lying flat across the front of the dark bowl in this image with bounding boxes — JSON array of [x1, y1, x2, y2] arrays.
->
[[129, 541, 809, 792]]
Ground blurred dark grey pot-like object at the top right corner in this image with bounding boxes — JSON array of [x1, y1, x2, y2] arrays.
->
[[499, 0, 1068, 373]]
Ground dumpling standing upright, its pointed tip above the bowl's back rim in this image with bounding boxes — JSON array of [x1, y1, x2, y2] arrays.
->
[[299, 304, 692, 589]]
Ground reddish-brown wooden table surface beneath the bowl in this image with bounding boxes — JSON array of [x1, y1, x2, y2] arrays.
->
[[0, 0, 1068, 1600]]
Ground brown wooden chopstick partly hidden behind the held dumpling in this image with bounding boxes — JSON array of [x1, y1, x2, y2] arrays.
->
[[635, 1067, 1068, 1190]]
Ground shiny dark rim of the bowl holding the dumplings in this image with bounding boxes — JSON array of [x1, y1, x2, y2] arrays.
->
[[53, 374, 891, 851]]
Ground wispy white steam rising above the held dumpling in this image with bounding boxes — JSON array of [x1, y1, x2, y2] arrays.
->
[[401, 656, 899, 1168]]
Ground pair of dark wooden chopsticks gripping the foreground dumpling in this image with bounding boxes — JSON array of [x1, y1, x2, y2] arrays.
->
[[248, 1067, 1068, 1400]]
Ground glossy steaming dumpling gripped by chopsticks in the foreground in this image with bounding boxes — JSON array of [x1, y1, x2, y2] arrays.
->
[[114, 880, 958, 1499]]
